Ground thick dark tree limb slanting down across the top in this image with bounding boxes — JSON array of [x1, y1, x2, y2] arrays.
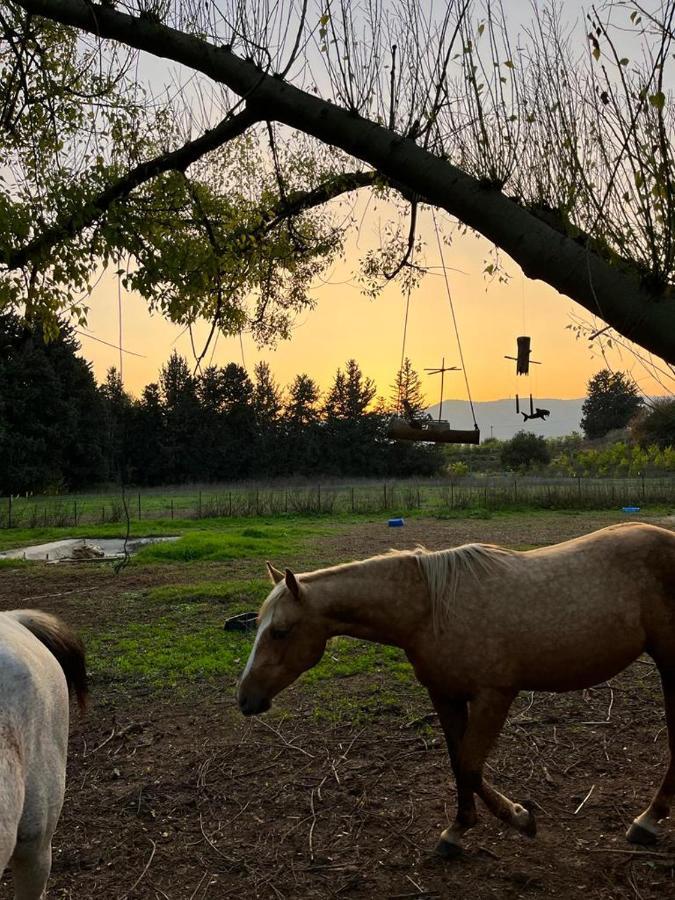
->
[[11, 0, 675, 362]]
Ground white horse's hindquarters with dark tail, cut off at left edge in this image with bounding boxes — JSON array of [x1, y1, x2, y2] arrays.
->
[[0, 609, 87, 900]]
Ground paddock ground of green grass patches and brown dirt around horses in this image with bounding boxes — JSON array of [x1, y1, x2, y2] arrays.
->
[[0, 510, 675, 900]]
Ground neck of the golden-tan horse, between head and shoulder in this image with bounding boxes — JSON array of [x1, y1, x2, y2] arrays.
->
[[316, 555, 430, 648]]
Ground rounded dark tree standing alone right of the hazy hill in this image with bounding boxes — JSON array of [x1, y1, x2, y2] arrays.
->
[[581, 369, 642, 439]]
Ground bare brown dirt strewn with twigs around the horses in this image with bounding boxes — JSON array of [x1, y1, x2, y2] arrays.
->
[[0, 515, 675, 900]]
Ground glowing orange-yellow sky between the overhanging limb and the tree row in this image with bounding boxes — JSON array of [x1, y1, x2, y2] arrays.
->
[[80, 201, 664, 403]]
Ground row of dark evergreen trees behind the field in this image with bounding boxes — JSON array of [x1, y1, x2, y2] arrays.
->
[[0, 314, 444, 495]]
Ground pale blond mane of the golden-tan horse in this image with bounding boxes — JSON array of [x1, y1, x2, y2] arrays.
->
[[413, 544, 516, 632]]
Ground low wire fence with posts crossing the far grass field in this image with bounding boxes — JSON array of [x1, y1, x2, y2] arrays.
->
[[0, 475, 675, 529]]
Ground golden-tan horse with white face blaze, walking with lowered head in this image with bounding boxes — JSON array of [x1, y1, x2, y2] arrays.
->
[[239, 523, 675, 857]]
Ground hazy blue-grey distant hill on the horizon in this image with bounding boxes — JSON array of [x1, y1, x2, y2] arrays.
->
[[428, 397, 584, 441]]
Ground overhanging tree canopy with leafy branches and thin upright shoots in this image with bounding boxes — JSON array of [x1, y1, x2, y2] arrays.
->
[[0, 0, 675, 362]]
